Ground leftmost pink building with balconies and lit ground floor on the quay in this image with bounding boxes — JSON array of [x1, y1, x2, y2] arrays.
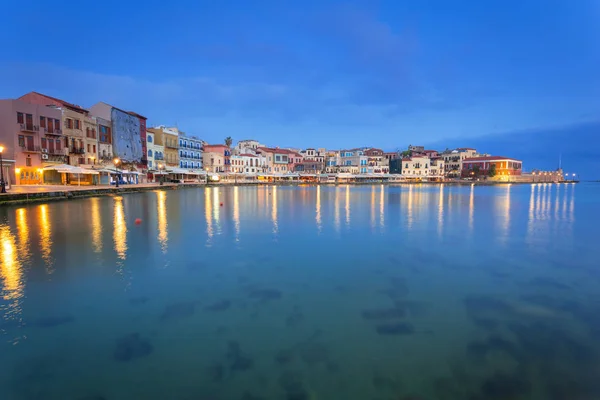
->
[[0, 99, 65, 185]]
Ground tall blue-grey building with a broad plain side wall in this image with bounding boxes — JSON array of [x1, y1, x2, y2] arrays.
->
[[90, 102, 146, 167]]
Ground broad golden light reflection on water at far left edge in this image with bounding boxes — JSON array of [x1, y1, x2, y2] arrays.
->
[[0, 226, 24, 325]]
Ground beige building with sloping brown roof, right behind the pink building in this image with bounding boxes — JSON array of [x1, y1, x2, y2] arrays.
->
[[19, 92, 98, 166]]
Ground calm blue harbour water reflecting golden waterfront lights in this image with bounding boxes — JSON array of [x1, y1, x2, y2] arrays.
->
[[0, 183, 600, 400]]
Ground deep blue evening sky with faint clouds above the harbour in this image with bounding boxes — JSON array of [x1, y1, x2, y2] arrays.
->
[[0, 0, 600, 176]]
